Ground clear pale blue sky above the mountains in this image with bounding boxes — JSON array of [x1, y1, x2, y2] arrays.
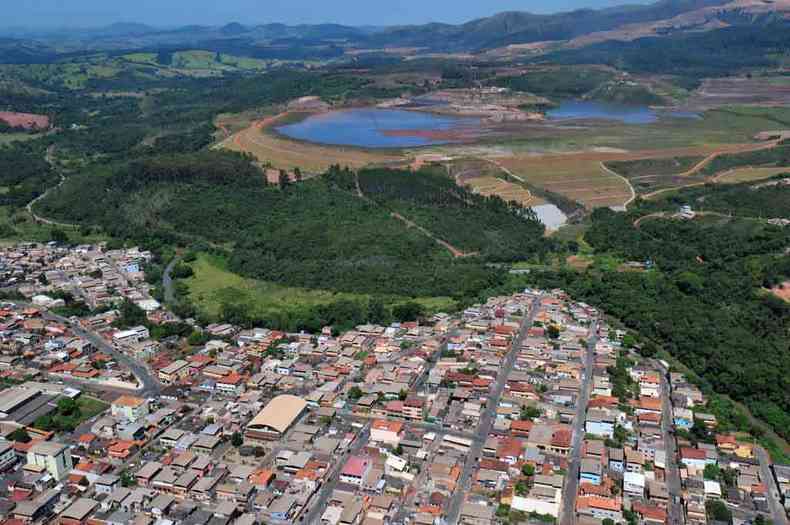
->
[[9, 0, 646, 27]]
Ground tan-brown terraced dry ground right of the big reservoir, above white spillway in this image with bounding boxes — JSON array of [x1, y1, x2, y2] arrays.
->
[[498, 153, 631, 208]]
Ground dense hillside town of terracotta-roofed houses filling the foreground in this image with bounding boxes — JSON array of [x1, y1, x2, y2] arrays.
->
[[0, 244, 790, 525]]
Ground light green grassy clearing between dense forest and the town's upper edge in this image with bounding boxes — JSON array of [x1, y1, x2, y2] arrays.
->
[[185, 254, 455, 317]]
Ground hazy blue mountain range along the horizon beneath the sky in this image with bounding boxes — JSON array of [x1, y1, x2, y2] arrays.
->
[[0, 0, 790, 58]]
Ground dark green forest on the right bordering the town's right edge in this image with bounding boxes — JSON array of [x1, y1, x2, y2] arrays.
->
[[531, 185, 790, 438]]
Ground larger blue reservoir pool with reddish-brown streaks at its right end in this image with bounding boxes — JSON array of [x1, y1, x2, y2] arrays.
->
[[275, 108, 480, 148]]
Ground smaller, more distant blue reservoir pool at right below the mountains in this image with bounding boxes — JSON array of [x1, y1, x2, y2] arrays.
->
[[546, 100, 699, 124]]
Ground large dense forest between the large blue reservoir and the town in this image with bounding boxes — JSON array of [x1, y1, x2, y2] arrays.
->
[[40, 152, 553, 299]]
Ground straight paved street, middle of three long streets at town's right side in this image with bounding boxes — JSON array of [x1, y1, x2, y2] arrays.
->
[[560, 323, 598, 525]]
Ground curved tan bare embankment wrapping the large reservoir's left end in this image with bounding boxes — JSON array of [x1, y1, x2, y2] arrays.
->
[[218, 113, 404, 173]]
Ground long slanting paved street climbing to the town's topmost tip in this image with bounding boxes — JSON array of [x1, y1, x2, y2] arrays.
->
[[447, 299, 540, 525]]
